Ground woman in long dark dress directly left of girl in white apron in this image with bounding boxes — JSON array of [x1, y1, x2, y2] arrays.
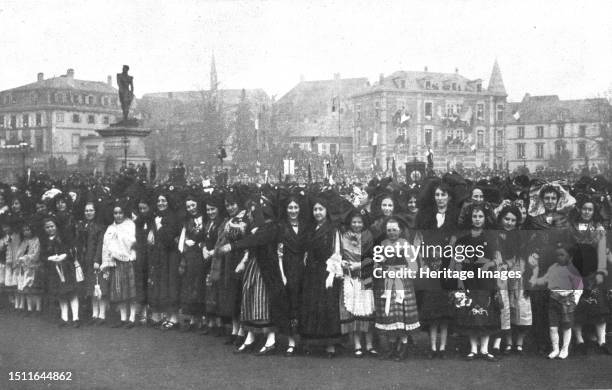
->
[[298, 200, 342, 357]]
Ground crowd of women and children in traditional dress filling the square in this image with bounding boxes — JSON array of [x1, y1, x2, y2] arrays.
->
[[0, 167, 612, 361]]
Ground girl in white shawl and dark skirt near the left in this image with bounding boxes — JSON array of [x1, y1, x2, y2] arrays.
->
[[100, 202, 138, 329]]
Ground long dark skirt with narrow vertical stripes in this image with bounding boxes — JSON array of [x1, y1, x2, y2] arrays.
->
[[240, 258, 272, 332]]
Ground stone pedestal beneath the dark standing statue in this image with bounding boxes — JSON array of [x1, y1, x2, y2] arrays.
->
[[96, 124, 151, 173]]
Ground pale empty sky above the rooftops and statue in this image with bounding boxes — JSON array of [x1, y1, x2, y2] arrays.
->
[[0, 0, 612, 101]]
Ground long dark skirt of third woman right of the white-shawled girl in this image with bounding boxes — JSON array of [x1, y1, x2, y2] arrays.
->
[[180, 247, 206, 316]]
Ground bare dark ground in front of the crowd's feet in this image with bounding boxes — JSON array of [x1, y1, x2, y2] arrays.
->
[[0, 311, 612, 389]]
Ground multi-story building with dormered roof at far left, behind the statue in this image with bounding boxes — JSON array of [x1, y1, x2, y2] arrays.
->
[[0, 69, 121, 176]]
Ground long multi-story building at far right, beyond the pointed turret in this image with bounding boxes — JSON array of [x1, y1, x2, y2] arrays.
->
[[505, 94, 612, 171]]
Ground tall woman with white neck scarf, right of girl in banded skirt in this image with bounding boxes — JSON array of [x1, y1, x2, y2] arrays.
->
[[414, 181, 458, 359]]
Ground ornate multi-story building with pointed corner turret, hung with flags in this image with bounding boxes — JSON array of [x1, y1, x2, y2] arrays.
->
[[351, 62, 507, 169]]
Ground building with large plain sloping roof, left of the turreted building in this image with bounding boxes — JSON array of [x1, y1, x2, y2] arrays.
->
[[274, 73, 370, 166]]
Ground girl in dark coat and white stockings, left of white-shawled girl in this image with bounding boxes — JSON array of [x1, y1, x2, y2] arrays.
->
[[41, 218, 80, 327]]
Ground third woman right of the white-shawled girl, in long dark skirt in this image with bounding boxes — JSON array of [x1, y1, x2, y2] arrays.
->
[[178, 195, 206, 331]]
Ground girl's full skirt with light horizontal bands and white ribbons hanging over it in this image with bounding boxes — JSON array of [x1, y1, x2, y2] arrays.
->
[[374, 279, 420, 335]]
